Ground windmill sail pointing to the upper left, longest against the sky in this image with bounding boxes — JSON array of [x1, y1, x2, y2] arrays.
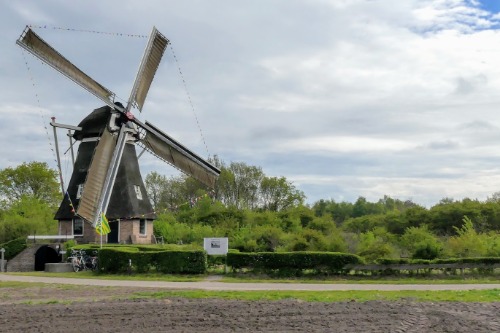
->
[[16, 27, 115, 107]]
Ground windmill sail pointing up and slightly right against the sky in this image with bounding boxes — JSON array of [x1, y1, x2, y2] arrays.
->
[[127, 27, 169, 111]]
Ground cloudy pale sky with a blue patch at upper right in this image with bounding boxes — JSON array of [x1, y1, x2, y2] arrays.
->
[[0, 0, 500, 207]]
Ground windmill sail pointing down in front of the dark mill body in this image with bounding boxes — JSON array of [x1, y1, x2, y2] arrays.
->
[[76, 129, 116, 222]]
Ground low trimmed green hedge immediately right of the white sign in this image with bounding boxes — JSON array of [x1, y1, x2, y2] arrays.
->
[[227, 252, 363, 272]]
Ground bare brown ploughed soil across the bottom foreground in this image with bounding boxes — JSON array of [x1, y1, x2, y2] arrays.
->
[[0, 285, 500, 333]]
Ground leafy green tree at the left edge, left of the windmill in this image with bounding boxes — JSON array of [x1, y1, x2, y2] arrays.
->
[[0, 162, 62, 206]]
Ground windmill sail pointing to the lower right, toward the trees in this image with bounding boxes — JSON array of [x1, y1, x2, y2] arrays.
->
[[138, 120, 220, 188]]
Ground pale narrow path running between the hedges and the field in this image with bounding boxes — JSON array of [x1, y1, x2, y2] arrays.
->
[[0, 274, 500, 291]]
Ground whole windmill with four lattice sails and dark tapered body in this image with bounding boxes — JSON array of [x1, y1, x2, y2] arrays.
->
[[16, 26, 220, 242]]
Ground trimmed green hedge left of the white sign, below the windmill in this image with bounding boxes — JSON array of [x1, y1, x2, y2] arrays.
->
[[99, 247, 207, 274]]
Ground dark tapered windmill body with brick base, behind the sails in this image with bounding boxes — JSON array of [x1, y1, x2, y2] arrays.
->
[[55, 106, 156, 244]]
